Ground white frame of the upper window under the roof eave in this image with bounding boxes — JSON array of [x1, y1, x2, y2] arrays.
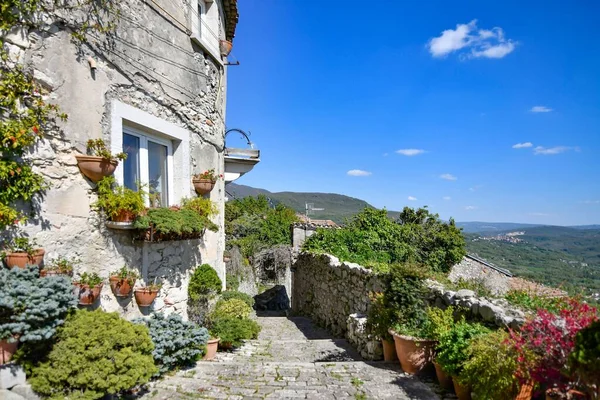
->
[[190, 0, 223, 65]]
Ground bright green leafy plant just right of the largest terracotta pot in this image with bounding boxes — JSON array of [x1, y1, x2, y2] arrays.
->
[[436, 321, 489, 380]]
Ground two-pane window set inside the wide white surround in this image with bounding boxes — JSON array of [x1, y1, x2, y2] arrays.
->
[[123, 127, 173, 207]]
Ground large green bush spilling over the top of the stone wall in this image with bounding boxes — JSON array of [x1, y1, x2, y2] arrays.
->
[[303, 207, 466, 272]]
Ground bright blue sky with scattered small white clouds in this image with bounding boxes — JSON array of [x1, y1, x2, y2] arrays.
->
[[227, 0, 600, 225]]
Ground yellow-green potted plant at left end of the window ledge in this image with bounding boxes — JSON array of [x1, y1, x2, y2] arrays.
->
[[93, 176, 146, 225]]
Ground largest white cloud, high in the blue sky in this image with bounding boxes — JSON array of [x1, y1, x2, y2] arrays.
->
[[427, 19, 517, 58]]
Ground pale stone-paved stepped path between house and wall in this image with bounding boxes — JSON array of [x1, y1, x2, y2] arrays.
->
[[143, 316, 439, 400]]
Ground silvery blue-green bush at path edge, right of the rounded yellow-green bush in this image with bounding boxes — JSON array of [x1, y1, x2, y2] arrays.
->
[[140, 314, 208, 374]]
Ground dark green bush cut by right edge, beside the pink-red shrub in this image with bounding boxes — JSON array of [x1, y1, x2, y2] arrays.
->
[[570, 321, 600, 399]]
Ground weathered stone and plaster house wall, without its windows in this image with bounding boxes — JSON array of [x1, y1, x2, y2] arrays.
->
[[4, 0, 233, 317]]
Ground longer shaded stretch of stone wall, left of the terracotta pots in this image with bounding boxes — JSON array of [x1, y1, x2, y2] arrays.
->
[[292, 253, 383, 360]]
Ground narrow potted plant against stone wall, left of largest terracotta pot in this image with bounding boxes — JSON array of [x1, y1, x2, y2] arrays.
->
[[366, 293, 398, 362]]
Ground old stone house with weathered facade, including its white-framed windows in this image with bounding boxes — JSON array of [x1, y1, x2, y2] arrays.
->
[[0, 0, 238, 317]]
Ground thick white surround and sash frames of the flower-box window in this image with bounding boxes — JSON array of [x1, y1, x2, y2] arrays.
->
[[110, 100, 192, 207]]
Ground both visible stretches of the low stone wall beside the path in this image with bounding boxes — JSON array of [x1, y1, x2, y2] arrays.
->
[[292, 253, 525, 360]]
